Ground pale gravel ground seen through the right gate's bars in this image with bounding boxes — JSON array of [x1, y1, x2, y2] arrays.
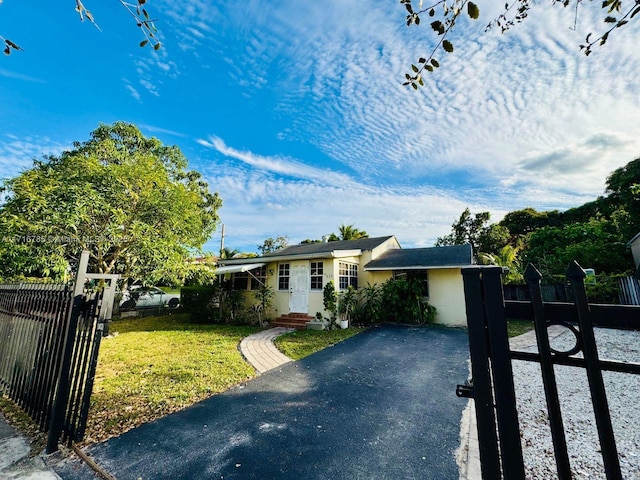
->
[[513, 328, 640, 480]]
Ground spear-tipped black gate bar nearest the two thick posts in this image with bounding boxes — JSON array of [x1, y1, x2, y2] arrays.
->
[[524, 264, 572, 480]]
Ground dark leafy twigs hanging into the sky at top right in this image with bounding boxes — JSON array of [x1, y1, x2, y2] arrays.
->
[[400, 0, 640, 90]]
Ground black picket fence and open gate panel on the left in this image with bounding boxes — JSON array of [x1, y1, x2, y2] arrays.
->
[[0, 253, 117, 453]]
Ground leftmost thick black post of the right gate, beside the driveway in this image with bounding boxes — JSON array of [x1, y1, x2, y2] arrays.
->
[[462, 268, 501, 480]]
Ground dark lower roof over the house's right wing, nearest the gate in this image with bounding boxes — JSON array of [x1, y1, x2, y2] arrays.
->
[[364, 244, 473, 271]]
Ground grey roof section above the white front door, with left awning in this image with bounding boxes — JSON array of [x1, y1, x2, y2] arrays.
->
[[220, 235, 393, 265]]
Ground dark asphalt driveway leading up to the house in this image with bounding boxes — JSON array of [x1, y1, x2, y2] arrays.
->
[[55, 327, 468, 480]]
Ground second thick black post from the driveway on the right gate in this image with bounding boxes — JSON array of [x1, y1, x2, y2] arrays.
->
[[482, 267, 524, 480]]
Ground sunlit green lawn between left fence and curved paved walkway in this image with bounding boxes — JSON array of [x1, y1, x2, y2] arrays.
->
[[86, 315, 260, 442]]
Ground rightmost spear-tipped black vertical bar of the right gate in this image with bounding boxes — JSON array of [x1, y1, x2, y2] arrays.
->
[[567, 260, 622, 480]]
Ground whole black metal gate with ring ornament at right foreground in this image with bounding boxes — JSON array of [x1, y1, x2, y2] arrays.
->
[[457, 262, 640, 480]]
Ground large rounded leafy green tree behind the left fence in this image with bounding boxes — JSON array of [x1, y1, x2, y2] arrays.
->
[[0, 122, 222, 281]]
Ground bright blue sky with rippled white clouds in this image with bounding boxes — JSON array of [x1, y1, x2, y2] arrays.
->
[[0, 0, 640, 255]]
